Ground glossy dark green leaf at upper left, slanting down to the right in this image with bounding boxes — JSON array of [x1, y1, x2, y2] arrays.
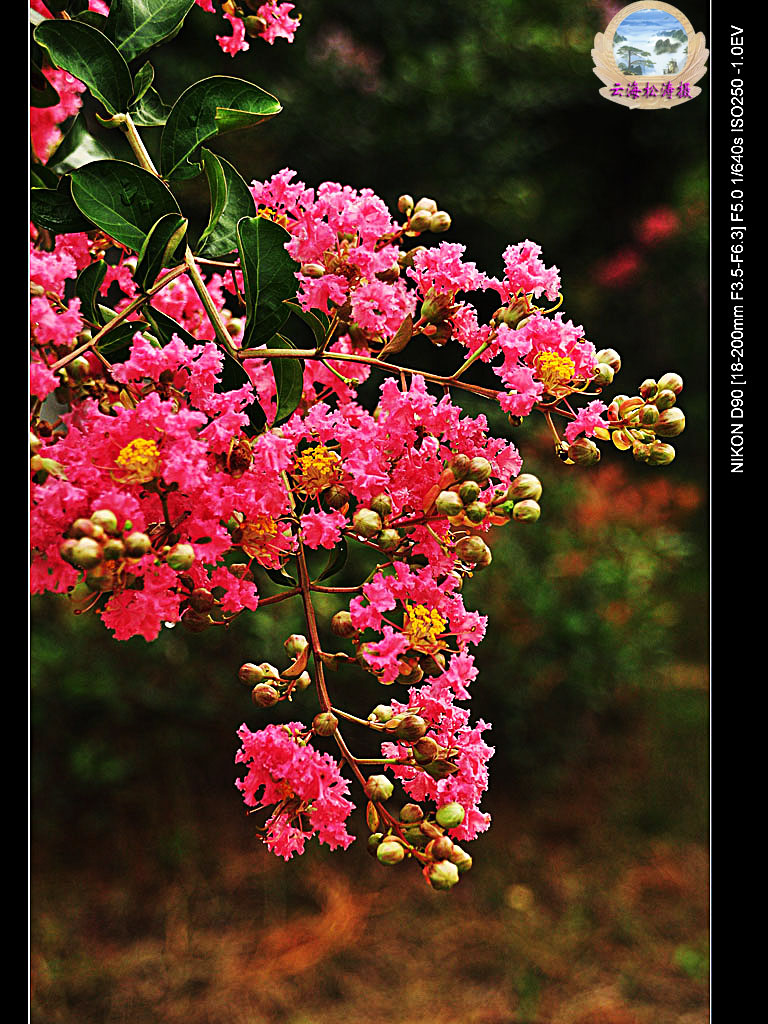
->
[[35, 20, 133, 114]]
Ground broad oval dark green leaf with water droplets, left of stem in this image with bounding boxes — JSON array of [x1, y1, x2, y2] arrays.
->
[[72, 160, 180, 252]]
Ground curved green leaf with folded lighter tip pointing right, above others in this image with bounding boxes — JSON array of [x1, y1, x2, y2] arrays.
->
[[160, 76, 283, 178]]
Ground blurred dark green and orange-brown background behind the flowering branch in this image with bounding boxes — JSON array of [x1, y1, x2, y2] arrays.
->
[[31, 0, 709, 1024]]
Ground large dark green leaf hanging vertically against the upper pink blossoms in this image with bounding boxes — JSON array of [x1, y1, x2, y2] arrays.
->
[[237, 217, 299, 348]]
